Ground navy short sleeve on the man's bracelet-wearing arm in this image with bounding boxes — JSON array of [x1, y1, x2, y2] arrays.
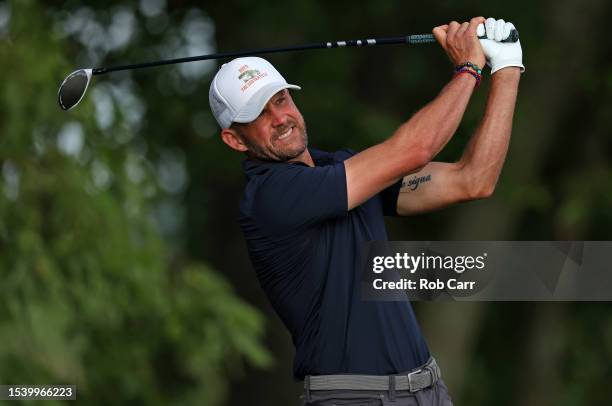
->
[[251, 162, 348, 234]]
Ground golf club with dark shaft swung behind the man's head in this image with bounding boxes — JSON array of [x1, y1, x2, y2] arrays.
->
[[57, 30, 518, 110]]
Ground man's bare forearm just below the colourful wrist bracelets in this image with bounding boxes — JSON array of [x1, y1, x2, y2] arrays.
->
[[392, 74, 475, 160]]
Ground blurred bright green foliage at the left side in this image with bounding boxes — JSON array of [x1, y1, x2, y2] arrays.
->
[[0, 1, 271, 405]]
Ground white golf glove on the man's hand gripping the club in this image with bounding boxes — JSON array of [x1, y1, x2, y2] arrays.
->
[[476, 18, 525, 75]]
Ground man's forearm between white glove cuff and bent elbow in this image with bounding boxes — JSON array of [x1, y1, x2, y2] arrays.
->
[[459, 68, 520, 197]]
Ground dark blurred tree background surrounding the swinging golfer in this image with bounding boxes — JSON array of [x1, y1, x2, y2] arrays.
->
[[0, 0, 612, 405]]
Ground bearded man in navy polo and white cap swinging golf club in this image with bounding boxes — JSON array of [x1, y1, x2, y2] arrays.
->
[[210, 17, 524, 405]]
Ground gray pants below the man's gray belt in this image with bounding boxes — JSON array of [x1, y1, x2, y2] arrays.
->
[[301, 379, 453, 406]]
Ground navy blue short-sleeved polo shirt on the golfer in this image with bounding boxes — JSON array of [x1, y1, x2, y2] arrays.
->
[[240, 149, 429, 380]]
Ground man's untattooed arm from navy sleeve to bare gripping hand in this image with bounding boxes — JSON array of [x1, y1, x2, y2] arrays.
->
[[345, 17, 485, 210]]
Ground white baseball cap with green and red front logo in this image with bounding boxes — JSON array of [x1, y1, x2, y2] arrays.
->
[[208, 56, 300, 128]]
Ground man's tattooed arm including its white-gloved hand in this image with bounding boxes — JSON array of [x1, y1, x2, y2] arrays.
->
[[397, 19, 524, 215]]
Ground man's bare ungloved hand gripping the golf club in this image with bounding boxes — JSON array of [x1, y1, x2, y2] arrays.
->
[[432, 17, 485, 67]]
